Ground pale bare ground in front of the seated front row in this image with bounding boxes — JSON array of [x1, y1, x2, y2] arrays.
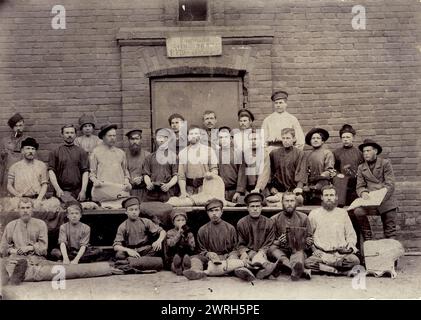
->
[[3, 256, 421, 300]]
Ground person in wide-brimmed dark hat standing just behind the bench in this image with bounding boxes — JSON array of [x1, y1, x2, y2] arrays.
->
[[305, 128, 335, 205]]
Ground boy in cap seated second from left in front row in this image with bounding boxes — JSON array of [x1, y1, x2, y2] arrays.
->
[[51, 201, 102, 264]]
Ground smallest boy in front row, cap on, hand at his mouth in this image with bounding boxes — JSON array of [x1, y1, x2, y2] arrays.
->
[[166, 209, 196, 276]]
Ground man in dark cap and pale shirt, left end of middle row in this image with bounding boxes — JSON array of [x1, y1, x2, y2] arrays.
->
[[7, 137, 48, 207]]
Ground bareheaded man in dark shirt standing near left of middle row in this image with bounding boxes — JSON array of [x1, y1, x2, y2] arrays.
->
[[48, 124, 89, 202]]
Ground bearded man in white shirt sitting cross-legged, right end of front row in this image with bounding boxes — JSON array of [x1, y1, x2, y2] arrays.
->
[[305, 185, 360, 274]]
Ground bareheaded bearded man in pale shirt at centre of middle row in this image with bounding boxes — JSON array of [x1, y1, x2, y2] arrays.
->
[[178, 125, 218, 198]]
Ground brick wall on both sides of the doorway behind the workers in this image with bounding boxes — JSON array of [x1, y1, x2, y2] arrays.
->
[[0, 0, 421, 249]]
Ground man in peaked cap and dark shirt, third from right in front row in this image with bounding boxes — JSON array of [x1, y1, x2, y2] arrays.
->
[[237, 193, 276, 279]]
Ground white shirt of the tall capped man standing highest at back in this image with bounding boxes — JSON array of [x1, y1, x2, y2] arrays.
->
[[262, 111, 305, 150]]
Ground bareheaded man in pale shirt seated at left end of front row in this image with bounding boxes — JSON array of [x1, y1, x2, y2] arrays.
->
[[0, 198, 48, 284]]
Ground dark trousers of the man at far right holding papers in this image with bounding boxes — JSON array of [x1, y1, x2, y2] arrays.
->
[[354, 207, 397, 240]]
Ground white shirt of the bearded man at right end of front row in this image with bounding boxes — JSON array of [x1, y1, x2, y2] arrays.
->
[[308, 207, 357, 252]]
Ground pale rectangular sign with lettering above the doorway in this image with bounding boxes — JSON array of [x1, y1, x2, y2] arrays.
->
[[167, 36, 222, 58]]
